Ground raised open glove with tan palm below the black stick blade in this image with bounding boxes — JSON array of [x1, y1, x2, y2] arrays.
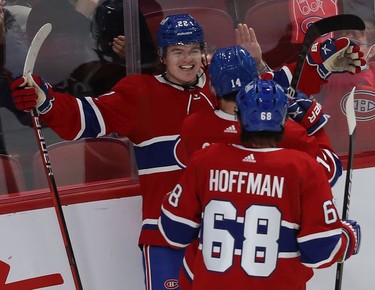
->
[[306, 37, 366, 79]]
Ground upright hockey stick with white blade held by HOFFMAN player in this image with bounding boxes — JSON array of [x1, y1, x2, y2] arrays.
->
[[335, 87, 357, 290]]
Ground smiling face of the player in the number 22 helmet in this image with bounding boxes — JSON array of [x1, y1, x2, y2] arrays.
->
[[164, 44, 202, 85]]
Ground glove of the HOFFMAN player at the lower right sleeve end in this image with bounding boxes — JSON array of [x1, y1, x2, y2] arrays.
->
[[340, 219, 361, 262]]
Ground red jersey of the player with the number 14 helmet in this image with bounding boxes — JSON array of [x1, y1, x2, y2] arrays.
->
[[181, 110, 342, 186]]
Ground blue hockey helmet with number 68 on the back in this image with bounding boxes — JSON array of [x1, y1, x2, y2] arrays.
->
[[236, 79, 288, 132]]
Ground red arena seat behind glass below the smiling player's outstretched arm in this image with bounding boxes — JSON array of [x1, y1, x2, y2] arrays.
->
[[33, 137, 134, 188]]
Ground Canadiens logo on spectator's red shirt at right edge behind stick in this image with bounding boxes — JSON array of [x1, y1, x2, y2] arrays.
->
[[340, 90, 375, 121]]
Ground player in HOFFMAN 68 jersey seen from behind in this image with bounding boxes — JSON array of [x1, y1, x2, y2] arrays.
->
[[159, 80, 360, 290]]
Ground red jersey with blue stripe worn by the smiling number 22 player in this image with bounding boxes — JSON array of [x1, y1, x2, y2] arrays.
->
[[41, 70, 216, 245]]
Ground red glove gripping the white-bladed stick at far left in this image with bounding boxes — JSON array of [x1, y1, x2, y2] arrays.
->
[[11, 74, 54, 114]]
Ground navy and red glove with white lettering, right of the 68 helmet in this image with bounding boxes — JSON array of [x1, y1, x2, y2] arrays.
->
[[288, 92, 329, 136]]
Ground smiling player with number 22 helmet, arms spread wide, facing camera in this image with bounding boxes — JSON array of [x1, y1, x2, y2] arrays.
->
[[12, 14, 368, 290]]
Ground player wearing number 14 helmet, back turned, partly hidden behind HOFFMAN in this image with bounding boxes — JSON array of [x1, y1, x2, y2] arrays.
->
[[181, 45, 342, 186]]
